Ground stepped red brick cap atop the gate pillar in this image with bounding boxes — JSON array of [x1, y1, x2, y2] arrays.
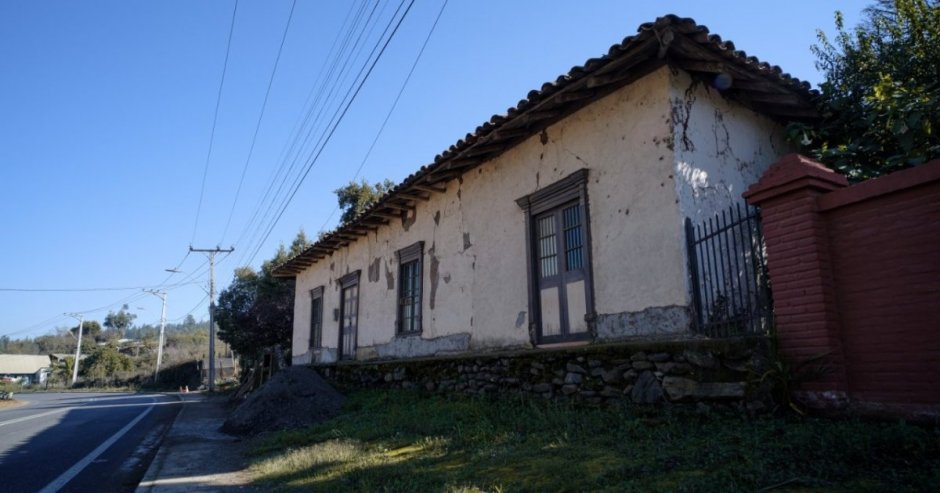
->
[[742, 153, 849, 205]]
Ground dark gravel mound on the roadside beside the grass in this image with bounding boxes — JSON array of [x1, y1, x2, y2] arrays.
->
[[222, 366, 345, 435]]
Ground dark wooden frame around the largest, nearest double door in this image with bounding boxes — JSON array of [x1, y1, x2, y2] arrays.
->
[[516, 168, 596, 345]]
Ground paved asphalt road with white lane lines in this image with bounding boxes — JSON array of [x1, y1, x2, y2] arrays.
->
[[0, 393, 180, 493]]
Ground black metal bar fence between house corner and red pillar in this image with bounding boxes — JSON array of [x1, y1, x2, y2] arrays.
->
[[685, 204, 773, 337]]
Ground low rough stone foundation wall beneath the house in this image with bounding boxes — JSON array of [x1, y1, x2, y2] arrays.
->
[[318, 337, 772, 412]]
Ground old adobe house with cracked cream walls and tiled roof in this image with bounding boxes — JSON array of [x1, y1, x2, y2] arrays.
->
[[275, 16, 815, 364]]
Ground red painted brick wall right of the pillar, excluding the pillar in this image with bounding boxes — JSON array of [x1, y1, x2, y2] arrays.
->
[[821, 169, 940, 404]]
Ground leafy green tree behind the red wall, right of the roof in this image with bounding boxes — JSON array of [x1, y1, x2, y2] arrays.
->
[[790, 0, 940, 181]]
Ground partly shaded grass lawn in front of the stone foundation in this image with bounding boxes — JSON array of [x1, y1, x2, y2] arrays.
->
[[251, 390, 940, 492]]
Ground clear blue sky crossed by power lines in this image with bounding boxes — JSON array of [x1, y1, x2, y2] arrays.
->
[[0, 0, 871, 338]]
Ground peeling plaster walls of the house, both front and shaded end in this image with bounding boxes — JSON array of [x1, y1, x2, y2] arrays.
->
[[293, 64, 786, 363]]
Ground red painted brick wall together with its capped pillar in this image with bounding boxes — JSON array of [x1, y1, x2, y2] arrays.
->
[[745, 155, 940, 405]]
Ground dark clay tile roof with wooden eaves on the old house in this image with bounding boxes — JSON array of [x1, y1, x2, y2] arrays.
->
[[274, 15, 818, 277]]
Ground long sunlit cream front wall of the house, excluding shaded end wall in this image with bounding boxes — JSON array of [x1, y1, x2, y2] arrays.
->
[[293, 68, 740, 359]]
